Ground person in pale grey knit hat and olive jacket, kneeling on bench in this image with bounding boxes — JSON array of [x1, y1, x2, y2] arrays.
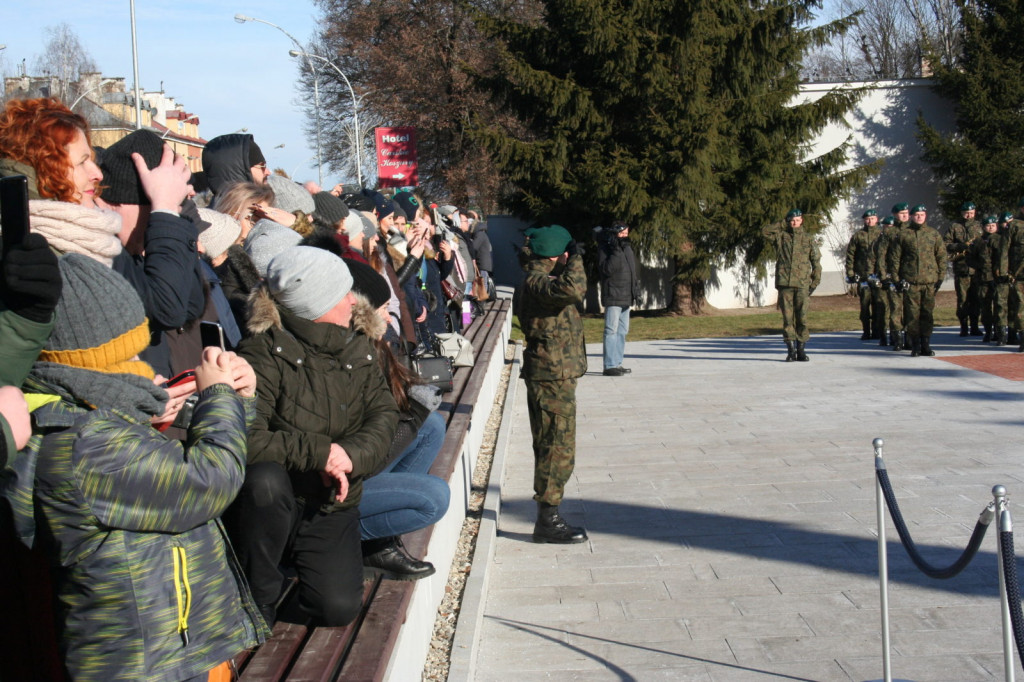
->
[[229, 246, 398, 626]]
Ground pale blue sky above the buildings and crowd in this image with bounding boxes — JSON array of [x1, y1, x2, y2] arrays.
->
[[0, 0, 349, 187]]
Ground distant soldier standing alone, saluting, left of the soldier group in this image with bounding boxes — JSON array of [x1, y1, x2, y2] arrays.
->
[[762, 209, 821, 363]]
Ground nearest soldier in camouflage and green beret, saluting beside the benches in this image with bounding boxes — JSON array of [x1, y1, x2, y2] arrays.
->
[[519, 225, 587, 544]]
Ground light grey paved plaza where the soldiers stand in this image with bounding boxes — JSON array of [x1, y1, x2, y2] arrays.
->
[[450, 329, 1024, 682]]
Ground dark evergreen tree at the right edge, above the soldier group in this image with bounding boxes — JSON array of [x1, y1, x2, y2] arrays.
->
[[918, 0, 1024, 216]]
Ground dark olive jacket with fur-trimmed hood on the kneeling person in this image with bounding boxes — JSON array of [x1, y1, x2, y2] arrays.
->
[[238, 288, 398, 511]]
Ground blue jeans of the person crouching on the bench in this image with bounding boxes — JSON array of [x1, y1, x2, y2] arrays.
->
[[359, 405, 451, 540]]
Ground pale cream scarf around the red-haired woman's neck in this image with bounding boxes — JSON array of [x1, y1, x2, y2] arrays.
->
[[29, 201, 123, 267]]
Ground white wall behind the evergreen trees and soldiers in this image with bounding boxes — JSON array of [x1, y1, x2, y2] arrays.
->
[[487, 80, 954, 311]]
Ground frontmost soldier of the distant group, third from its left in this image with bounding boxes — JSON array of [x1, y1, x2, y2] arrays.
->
[[888, 204, 947, 357]]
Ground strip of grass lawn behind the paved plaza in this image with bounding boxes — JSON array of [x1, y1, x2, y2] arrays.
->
[[512, 292, 958, 343]]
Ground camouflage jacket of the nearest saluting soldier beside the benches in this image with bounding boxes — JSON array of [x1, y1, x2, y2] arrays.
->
[[519, 250, 587, 381]]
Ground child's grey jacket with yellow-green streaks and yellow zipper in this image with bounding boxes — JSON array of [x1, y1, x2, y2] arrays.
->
[[0, 377, 269, 682]]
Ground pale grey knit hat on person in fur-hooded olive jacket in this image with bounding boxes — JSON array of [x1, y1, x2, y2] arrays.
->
[[266, 246, 352, 319]]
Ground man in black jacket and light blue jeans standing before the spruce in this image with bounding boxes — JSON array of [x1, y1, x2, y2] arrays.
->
[[597, 220, 640, 377]]
